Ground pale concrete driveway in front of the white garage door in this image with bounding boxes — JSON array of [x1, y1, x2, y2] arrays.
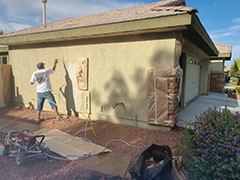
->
[[177, 93, 240, 127]]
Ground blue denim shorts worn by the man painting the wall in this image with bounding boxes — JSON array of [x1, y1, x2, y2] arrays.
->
[[37, 92, 57, 111]]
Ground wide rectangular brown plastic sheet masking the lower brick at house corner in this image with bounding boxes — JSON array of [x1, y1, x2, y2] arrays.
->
[[147, 66, 182, 126]]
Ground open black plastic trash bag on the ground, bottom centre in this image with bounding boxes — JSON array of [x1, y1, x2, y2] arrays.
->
[[128, 144, 172, 180]]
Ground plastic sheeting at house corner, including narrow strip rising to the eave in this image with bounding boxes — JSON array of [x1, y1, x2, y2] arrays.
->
[[147, 33, 184, 127]]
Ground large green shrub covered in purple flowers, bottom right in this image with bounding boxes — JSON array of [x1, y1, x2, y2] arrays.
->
[[183, 108, 240, 180]]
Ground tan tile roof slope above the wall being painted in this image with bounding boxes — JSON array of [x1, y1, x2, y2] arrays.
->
[[0, 0, 198, 38]]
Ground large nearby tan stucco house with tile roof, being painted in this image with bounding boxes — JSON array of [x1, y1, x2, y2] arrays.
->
[[0, 0, 218, 129]]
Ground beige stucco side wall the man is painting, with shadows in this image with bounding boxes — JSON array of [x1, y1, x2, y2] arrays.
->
[[9, 33, 175, 127]]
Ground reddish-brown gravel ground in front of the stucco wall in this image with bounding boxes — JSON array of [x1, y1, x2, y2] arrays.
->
[[0, 107, 184, 180]]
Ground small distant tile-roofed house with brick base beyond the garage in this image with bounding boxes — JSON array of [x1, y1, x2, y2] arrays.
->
[[209, 43, 232, 92]]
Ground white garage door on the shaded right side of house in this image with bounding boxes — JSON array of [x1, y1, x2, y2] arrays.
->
[[185, 57, 201, 104]]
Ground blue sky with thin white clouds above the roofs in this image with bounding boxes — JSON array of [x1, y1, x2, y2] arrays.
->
[[0, 0, 240, 65]]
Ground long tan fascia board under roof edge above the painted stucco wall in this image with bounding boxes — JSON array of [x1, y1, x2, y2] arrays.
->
[[0, 14, 191, 45]]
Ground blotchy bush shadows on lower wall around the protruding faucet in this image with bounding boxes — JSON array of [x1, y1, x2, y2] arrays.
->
[[92, 68, 147, 120]]
